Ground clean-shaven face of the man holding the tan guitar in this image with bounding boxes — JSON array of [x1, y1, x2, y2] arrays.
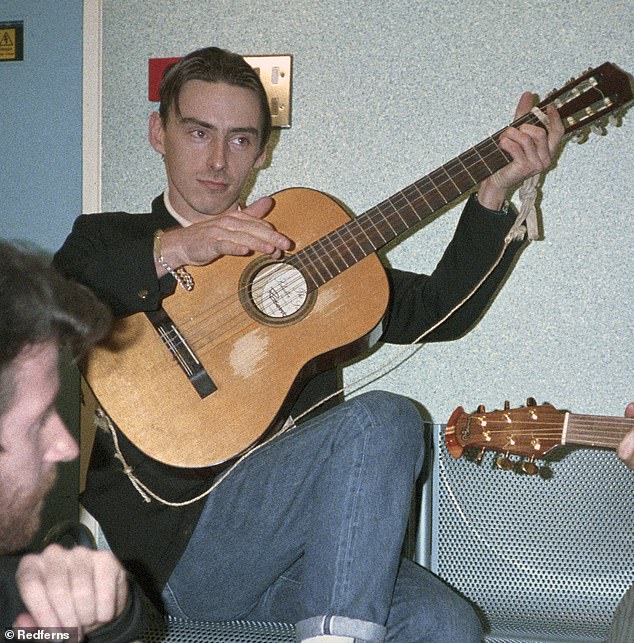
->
[[149, 80, 265, 222]]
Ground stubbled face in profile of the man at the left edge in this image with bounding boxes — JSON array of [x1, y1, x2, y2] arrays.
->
[[0, 342, 78, 554]]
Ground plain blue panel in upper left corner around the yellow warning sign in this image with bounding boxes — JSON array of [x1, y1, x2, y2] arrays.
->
[[0, 0, 83, 251]]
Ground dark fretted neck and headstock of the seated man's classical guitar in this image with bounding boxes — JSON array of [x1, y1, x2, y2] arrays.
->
[[285, 63, 633, 290]]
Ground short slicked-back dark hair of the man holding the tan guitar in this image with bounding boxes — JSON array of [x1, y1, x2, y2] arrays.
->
[[159, 47, 271, 151]]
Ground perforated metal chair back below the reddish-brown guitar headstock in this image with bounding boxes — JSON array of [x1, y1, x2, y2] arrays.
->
[[431, 426, 634, 643]]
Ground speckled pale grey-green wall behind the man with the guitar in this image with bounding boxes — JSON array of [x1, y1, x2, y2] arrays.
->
[[103, 0, 634, 423]]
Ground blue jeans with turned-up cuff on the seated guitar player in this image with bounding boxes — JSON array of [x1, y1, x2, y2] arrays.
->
[[163, 392, 480, 643]]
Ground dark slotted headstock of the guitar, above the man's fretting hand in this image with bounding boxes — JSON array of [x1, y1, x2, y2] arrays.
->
[[538, 62, 634, 140]]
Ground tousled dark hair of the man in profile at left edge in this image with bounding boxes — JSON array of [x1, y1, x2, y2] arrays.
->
[[0, 241, 112, 417]]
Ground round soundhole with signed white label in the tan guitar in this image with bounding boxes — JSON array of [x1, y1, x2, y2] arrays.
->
[[240, 257, 317, 326]]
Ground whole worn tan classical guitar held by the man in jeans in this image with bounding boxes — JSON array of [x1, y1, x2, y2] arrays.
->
[[84, 63, 632, 468]]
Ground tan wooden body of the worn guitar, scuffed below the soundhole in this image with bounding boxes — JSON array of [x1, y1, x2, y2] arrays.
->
[[84, 188, 389, 467]]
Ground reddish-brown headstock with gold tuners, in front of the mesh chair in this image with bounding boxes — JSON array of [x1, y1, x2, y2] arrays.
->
[[445, 399, 566, 472]]
